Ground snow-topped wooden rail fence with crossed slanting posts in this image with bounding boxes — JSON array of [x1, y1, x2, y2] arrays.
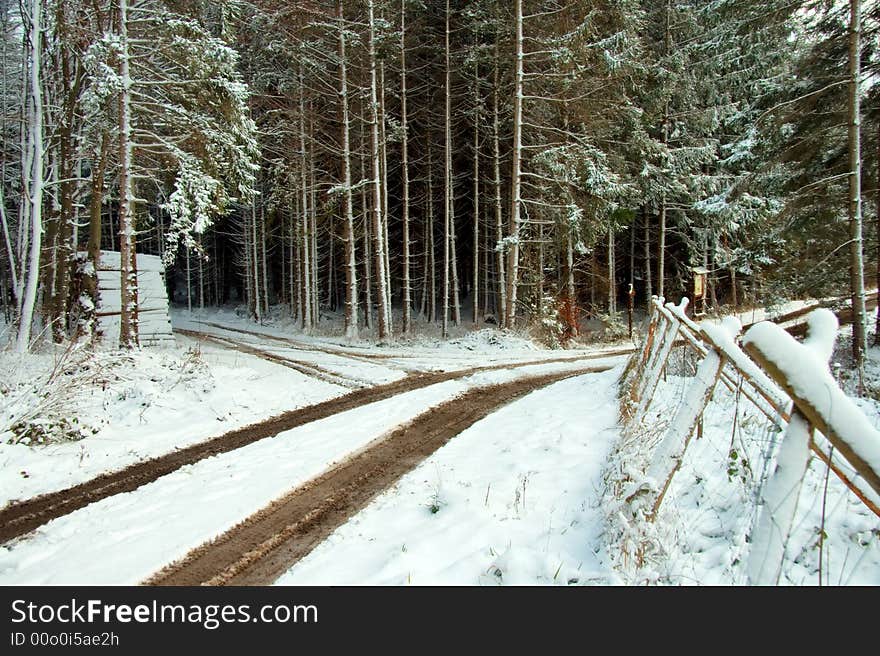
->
[[621, 297, 880, 584]]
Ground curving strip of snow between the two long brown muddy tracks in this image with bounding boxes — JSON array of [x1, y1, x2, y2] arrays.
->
[[0, 362, 620, 585]]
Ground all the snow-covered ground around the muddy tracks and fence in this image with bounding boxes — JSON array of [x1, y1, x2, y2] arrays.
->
[[0, 304, 880, 585]]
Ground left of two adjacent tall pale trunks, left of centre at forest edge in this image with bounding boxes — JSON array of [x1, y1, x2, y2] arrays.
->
[[340, 0, 360, 339]]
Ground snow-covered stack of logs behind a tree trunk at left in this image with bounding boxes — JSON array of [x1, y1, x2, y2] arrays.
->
[[97, 251, 174, 346]]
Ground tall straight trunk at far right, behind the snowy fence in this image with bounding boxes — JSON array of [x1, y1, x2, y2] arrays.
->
[[849, 0, 868, 368]]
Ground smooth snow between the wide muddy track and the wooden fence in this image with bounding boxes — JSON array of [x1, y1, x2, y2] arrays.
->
[[278, 368, 620, 585]]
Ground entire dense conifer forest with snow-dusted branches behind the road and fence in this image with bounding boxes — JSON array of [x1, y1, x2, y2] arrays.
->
[[0, 0, 880, 358]]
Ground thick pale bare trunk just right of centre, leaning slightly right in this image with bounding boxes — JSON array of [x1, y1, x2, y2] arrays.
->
[[504, 0, 523, 328]]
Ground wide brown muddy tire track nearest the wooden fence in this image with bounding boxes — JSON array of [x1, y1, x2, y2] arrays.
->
[[144, 365, 611, 585]]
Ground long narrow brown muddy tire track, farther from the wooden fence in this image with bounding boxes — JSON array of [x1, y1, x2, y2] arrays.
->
[[0, 344, 624, 544]]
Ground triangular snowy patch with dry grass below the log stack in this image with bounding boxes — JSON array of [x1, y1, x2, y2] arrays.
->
[[0, 335, 349, 507]]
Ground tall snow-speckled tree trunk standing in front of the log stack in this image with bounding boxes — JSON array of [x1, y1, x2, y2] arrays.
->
[[119, 0, 138, 349]]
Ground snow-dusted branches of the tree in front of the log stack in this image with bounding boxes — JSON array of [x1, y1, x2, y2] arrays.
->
[[84, 1, 258, 264]]
